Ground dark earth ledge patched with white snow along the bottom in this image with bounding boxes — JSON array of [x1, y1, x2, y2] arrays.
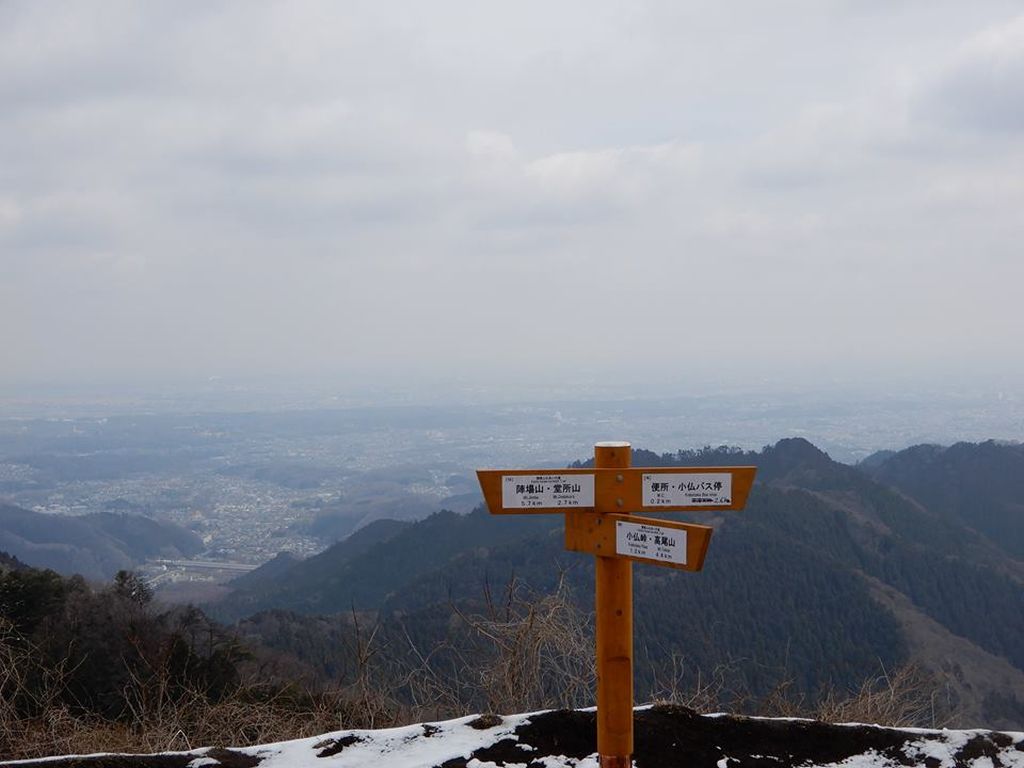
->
[[0, 707, 1024, 768]]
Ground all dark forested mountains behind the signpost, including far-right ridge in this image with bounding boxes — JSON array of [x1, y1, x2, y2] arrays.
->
[[220, 439, 1024, 727]]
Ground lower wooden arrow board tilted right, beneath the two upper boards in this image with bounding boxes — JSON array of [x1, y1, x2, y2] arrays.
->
[[565, 511, 713, 570]]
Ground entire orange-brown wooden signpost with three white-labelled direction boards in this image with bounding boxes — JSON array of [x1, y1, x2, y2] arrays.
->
[[476, 442, 757, 768]]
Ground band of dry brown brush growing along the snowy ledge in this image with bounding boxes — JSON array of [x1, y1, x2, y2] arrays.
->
[[0, 579, 946, 759]]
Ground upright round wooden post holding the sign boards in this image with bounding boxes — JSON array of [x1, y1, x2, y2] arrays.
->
[[594, 442, 633, 768]]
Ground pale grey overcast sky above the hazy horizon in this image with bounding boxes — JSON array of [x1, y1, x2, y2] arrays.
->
[[0, 0, 1024, 403]]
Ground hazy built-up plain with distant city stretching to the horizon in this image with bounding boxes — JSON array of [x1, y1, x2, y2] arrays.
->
[[0, 392, 1024, 588]]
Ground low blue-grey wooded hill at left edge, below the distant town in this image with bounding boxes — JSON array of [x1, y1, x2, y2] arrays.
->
[[0, 502, 203, 580]]
